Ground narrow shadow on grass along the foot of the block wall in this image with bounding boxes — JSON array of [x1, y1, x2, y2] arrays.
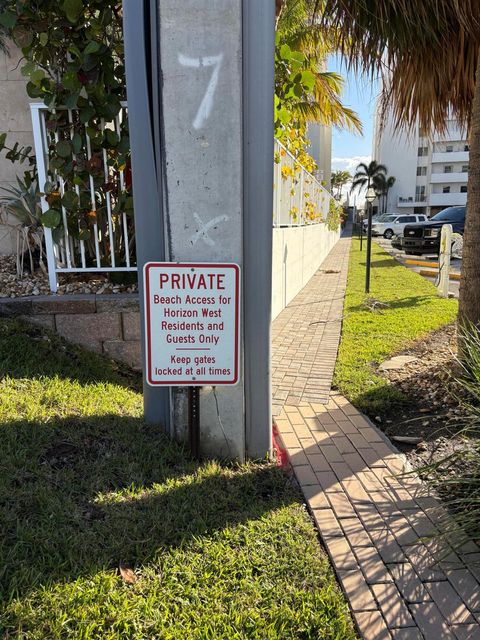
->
[[0, 318, 142, 391]]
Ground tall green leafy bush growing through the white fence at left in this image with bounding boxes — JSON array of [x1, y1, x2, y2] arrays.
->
[[0, 0, 135, 266]]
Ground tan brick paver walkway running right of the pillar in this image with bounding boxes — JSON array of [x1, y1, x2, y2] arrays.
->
[[273, 228, 480, 640]]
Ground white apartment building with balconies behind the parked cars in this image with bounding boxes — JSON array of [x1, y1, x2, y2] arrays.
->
[[373, 106, 469, 216]]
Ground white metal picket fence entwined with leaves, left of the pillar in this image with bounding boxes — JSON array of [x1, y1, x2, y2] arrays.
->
[[30, 104, 136, 291]]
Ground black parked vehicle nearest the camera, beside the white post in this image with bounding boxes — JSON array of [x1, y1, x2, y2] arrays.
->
[[403, 207, 465, 255]]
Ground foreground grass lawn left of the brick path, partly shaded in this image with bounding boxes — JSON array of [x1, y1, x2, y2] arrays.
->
[[0, 320, 356, 640]]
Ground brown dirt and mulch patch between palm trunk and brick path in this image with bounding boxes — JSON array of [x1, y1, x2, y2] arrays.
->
[[373, 325, 476, 467]]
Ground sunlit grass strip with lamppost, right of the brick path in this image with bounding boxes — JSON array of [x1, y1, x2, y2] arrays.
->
[[334, 238, 458, 414]]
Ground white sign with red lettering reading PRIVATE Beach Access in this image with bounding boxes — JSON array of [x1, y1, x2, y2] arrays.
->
[[144, 262, 240, 386]]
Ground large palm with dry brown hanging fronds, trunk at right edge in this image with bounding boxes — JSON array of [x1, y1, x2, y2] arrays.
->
[[311, 0, 480, 326]]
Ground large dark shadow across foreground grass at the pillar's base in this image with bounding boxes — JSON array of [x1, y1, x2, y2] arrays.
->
[[0, 415, 298, 601]]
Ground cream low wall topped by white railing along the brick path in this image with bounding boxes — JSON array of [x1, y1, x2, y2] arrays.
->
[[272, 224, 340, 319]]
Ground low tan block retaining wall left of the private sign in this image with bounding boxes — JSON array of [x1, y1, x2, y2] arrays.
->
[[0, 294, 142, 370]]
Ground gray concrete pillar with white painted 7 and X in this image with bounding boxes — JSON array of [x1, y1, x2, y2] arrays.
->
[[125, 0, 274, 459]]
